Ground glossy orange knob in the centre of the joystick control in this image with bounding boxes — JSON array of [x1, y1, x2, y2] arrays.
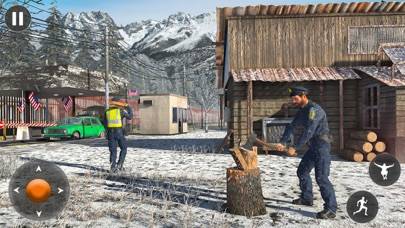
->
[[25, 179, 51, 203]]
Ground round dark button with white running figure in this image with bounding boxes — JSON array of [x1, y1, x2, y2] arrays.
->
[[346, 191, 378, 223]]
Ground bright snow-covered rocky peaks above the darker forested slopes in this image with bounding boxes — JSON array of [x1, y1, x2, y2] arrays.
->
[[123, 13, 215, 54]]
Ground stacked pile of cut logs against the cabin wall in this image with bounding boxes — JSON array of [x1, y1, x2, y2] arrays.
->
[[340, 131, 387, 162]]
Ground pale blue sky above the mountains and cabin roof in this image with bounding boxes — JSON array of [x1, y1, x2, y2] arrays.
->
[[11, 0, 382, 25]]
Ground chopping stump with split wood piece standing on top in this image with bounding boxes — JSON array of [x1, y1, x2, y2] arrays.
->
[[226, 147, 266, 217]]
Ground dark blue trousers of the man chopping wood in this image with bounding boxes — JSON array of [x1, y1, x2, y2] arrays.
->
[[297, 141, 337, 212]]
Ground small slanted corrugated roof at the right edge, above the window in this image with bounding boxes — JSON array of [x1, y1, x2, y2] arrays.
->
[[354, 66, 405, 86]]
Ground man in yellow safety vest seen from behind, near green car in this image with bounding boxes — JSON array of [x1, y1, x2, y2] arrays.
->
[[104, 98, 133, 172]]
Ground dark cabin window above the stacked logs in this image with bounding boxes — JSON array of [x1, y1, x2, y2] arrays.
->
[[363, 85, 380, 129]]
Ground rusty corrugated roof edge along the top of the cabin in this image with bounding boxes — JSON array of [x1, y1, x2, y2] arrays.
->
[[220, 1, 405, 17]]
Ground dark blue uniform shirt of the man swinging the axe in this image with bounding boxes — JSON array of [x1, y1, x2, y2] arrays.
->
[[280, 101, 329, 149]]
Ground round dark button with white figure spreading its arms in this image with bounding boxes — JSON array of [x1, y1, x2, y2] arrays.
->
[[369, 153, 401, 186]]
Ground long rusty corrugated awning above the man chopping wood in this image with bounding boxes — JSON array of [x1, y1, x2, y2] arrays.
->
[[231, 67, 360, 82]]
